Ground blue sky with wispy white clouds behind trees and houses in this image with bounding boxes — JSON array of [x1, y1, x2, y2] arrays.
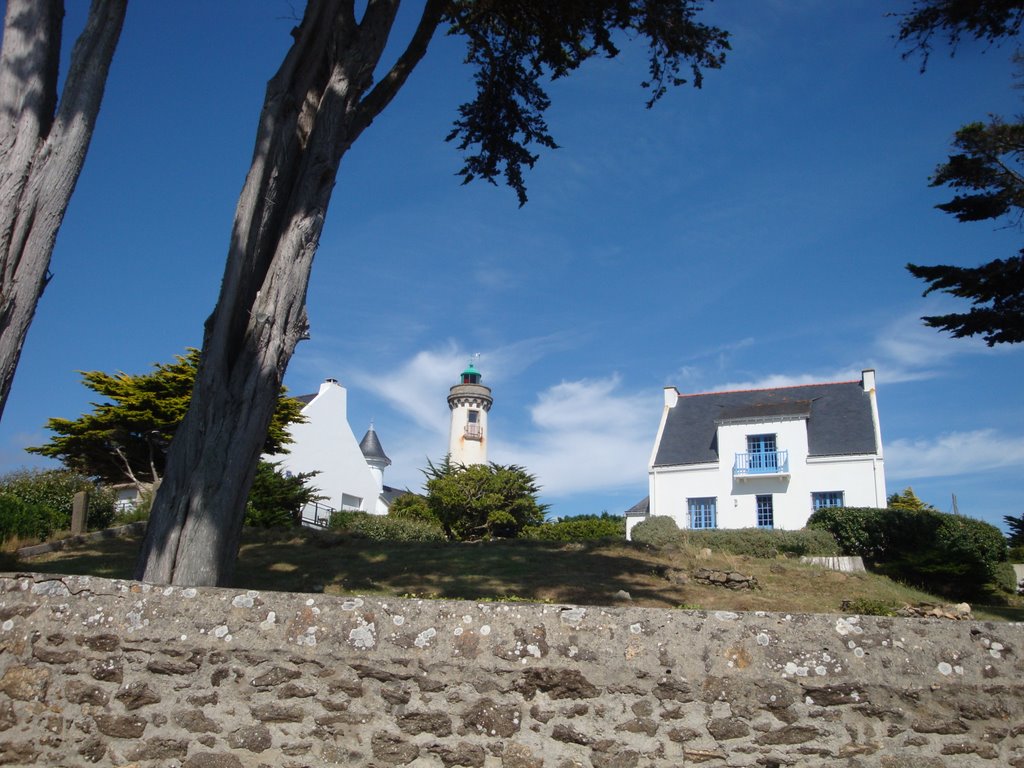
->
[[0, 0, 1024, 523]]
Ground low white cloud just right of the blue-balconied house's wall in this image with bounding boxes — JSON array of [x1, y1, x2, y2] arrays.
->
[[885, 429, 1024, 480]]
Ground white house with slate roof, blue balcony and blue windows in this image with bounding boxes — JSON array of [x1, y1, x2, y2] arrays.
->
[[627, 370, 886, 537]]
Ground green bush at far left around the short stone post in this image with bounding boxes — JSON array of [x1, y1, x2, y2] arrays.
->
[[0, 469, 116, 539]]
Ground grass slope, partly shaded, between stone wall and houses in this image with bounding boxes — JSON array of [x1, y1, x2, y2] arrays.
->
[[0, 529, 1024, 621]]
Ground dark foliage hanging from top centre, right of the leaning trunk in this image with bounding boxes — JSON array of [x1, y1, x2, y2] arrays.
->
[[446, 0, 729, 205]]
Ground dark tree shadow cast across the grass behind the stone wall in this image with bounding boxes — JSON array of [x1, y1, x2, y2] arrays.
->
[[2, 531, 685, 607]]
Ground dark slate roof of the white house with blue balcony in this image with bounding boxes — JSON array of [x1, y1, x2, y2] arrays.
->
[[654, 381, 878, 467]]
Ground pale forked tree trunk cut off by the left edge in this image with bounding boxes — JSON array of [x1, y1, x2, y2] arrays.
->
[[0, 0, 128, 416]]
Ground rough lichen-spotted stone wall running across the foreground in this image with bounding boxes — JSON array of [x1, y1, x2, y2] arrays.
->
[[0, 574, 1024, 768]]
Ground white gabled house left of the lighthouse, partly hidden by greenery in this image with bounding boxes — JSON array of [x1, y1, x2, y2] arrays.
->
[[267, 379, 396, 522]]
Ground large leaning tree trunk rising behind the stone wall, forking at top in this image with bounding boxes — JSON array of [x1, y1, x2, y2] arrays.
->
[[136, 0, 444, 585]]
